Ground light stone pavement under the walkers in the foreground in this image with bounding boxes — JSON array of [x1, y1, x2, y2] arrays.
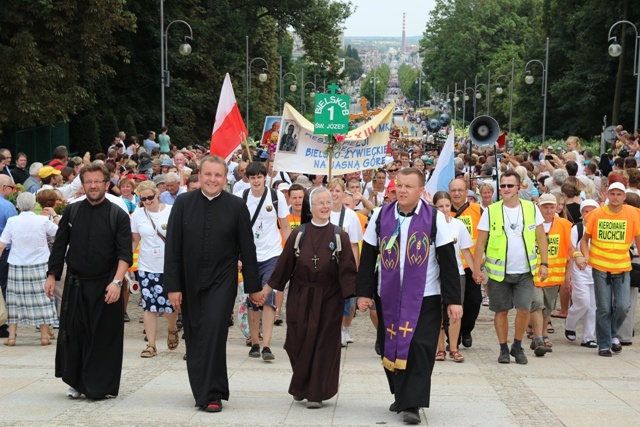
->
[[0, 298, 640, 427]]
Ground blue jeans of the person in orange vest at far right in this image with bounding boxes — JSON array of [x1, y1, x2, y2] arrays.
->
[[592, 268, 630, 350]]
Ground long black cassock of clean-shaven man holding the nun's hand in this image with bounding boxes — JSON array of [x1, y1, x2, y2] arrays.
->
[[164, 191, 262, 407]]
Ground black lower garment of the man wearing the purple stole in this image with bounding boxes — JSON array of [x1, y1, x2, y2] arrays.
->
[[375, 295, 442, 412]]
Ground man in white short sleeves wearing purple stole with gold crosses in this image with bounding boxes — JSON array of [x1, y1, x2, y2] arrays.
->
[[356, 168, 462, 424]]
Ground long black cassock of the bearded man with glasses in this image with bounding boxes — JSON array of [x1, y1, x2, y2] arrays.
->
[[48, 199, 133, 399]]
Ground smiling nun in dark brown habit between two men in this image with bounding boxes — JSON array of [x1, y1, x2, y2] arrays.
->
[[262, 187, 357, 409]]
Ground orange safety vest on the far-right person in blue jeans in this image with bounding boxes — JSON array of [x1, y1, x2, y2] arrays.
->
[[585, 205, 640, 273]]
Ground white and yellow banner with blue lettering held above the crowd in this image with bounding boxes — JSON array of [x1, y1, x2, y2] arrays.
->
[[273, 102, 395, 175]]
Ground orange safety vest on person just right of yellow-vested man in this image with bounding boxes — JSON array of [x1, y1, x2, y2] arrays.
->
[[533, 216, 573, 288]]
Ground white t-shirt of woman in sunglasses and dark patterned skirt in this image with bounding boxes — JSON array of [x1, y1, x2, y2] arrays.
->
[[131, 205, 171, 273]]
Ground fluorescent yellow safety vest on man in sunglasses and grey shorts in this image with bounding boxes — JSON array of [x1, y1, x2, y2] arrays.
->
[[484, 200, 537, 282]]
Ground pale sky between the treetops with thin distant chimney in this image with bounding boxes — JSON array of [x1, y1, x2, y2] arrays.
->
[[344, 0, 435, 37]]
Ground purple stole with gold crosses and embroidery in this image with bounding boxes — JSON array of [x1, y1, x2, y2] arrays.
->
[[379, 200, 433, 371]]
